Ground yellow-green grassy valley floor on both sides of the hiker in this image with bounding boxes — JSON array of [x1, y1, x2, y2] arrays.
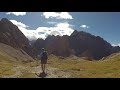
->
[[0, 52, 120, 78]]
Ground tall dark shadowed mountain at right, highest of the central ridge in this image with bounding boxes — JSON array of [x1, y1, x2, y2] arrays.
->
[[69, 31, 112, 59]]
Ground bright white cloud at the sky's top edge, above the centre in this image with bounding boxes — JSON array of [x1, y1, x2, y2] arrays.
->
[[42, 12, 73, 19]]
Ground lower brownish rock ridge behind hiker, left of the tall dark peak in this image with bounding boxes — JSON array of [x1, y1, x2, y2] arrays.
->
[[33, 36, 71, 57]]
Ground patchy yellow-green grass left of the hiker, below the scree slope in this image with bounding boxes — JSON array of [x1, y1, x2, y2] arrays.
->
[[0, 52, 39, 78]]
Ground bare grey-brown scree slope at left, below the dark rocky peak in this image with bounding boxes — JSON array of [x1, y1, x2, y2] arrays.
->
[[0, 43, 34, 62]]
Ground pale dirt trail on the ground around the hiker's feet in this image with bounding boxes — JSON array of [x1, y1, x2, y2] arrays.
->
[[2, 65, 70, 78]]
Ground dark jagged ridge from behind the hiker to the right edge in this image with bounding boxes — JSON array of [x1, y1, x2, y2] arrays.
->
[[33, 30, 120, 60]]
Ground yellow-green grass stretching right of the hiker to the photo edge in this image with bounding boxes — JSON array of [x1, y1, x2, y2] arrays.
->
[[49, 54, 120, 78]]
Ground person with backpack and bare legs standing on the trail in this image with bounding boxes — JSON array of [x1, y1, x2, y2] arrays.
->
[[40, 48, 48, 73]]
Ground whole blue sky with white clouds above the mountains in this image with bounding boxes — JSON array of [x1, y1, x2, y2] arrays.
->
[[0, 12, 120, 46]]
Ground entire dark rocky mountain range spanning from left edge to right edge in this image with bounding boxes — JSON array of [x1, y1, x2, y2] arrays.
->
[[0, 18, 120, 60]]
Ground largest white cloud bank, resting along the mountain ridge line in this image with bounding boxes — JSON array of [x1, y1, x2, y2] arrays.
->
[[10, 20, 74, 40]]
